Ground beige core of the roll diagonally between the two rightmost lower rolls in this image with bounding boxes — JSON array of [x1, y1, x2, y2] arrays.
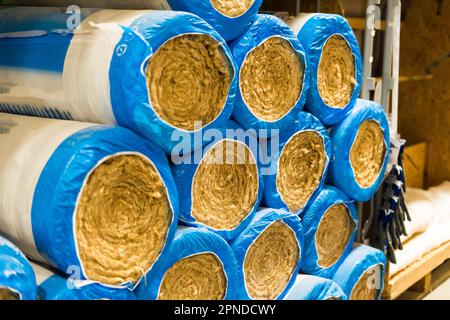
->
[[315, 203, 355, 269]]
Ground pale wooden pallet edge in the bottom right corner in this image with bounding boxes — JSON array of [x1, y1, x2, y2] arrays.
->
[[383, 242, 450, 300]]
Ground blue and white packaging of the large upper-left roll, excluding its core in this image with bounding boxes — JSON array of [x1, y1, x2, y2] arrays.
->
[[0, 7, 237, 153]]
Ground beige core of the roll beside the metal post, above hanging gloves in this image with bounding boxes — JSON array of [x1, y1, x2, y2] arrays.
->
[[350, 120, 386, 188]]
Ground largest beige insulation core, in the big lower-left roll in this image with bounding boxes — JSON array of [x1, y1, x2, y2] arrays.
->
[[75, 154, 173, 285]]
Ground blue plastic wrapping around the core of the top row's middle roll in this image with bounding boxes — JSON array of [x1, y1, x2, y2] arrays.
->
[[230, 14, 309, 130]]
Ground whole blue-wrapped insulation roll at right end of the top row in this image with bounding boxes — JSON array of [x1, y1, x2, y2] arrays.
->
[[289, 13, 362, 126]]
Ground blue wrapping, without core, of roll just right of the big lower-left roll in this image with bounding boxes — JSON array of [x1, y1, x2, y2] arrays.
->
[[172, 120, 264, 241]]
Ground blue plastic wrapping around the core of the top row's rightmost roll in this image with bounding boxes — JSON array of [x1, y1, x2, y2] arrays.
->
[[291, 14, 362, 126]]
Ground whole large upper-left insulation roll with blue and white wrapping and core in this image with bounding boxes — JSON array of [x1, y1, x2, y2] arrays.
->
[[0, 8, 236, 153]]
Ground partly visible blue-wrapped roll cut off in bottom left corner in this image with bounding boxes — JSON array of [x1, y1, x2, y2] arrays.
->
[[0, 236, 37, 300]]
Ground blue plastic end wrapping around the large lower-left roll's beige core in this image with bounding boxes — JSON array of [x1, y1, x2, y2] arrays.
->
[[31, 126, 178, 288]]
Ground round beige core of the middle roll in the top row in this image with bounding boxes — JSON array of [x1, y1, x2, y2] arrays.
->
[[239, 37, 303, 121]]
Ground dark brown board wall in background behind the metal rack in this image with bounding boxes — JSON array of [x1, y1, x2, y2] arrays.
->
[[399, 0, 450, 187]]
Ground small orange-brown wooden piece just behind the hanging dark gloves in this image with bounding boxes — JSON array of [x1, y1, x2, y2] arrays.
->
[[403, 143, 427, 189]]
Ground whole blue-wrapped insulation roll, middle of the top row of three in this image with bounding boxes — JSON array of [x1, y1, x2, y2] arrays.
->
[[230, 15, 309, 130]]
